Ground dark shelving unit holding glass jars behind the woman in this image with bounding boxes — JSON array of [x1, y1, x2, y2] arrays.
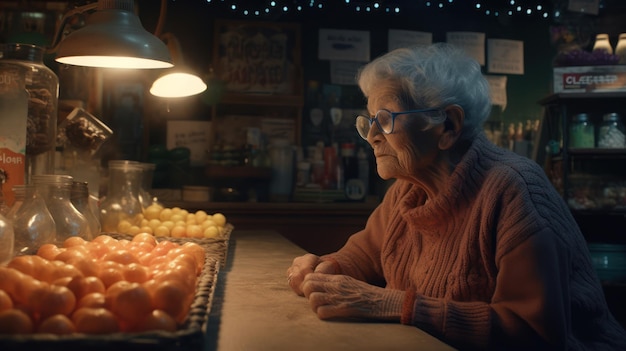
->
[[540, 92, 626, 244]]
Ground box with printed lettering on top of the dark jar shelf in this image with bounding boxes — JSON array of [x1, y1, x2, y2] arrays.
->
[[553, 65, 626, 93]]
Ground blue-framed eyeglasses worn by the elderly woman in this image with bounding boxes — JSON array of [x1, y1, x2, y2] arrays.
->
[[356, 107, 446, 140]]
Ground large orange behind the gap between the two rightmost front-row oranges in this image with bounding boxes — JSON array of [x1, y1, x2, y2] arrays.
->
[[105, 282, 153, 326]]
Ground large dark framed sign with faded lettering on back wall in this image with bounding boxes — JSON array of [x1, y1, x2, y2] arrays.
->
[[213, 20, 301, 95]]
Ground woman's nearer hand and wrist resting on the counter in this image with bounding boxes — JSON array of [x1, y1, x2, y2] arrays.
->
[[301, 273, 405, 322]]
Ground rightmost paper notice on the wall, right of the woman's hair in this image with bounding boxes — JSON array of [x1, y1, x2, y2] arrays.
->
[[487, 39, 524, 74]]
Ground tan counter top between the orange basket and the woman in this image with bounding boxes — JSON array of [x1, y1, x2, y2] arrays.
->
[[206, 228, 453, 351]]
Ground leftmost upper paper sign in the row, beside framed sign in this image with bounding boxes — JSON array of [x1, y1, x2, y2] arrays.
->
[[318, 28, 370, 62]]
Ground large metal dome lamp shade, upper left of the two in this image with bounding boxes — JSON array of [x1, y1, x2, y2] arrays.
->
[[56, 0, 173, 69]]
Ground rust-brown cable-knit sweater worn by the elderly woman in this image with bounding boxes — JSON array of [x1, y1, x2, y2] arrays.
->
[[323, 135, 626, 350]]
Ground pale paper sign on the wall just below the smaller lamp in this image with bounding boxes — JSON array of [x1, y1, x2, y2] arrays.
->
[[167, 121, 211, 166]]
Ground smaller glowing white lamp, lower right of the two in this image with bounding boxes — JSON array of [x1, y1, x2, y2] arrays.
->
[[150, 72, 207, 98]]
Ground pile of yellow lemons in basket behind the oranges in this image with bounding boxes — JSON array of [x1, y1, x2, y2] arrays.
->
[[117, 203, 227, 239]]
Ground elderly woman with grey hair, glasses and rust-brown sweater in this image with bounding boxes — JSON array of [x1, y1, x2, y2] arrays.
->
[[287, 44, 626, 350]]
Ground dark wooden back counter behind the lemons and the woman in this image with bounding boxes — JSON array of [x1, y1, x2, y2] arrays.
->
[[163, 201, 378, 255]]
